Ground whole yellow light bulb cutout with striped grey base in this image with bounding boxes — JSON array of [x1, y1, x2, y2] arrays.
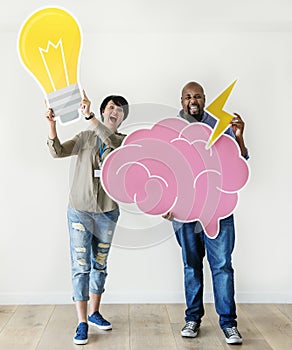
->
[[18, 8, 82, 124]]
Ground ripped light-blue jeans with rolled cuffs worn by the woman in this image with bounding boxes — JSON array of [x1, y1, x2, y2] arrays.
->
[[67, 207, 120, 301]]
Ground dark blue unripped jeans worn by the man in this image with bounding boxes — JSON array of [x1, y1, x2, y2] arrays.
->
[[173, 215, 237, 329]]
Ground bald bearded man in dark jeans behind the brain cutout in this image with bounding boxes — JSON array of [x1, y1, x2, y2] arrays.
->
[[164, 82, 248, 344]]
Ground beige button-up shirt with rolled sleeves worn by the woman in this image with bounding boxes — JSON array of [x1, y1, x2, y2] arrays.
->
[[47, 122, 126, 213]]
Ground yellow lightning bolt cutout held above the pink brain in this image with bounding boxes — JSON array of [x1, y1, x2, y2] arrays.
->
[[206, 80, 236, 149]]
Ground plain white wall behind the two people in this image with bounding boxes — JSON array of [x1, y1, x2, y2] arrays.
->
[[0, 0, 292, 304]]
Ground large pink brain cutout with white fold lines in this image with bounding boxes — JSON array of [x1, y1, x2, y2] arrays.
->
[[101, 118, 249, 238]]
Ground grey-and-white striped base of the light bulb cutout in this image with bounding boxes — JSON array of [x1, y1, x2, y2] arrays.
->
[[47, 84, 81, 124]]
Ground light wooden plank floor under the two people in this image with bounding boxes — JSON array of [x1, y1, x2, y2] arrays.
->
[[0, 304, 292, 350]]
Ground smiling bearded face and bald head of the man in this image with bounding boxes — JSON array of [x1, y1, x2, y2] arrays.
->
[[181, 82, 205, 121]]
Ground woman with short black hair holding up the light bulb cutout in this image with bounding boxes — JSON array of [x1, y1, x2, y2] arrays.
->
[[46, 92, 129, 344]]
